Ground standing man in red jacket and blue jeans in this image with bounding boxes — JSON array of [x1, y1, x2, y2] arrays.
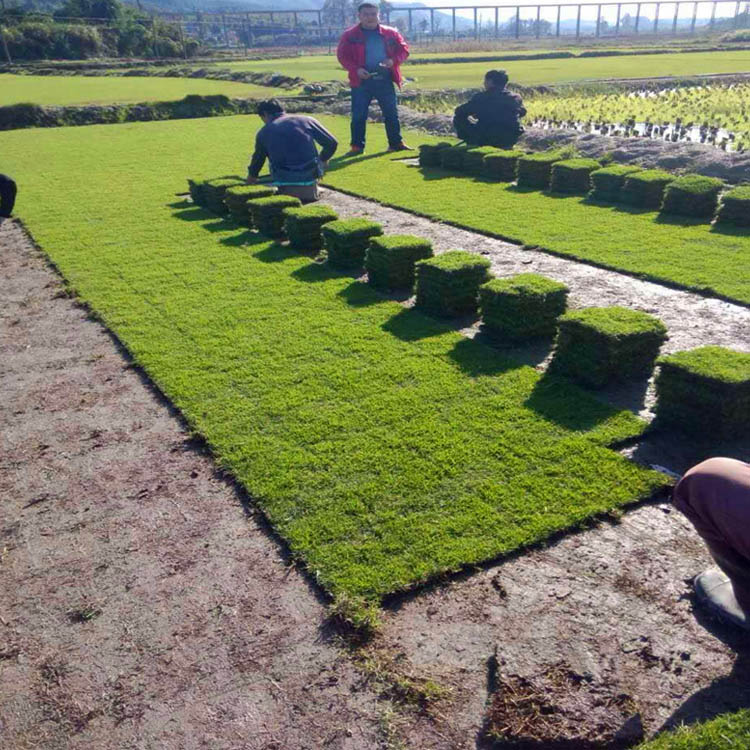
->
[[336, 2, 411, 156]]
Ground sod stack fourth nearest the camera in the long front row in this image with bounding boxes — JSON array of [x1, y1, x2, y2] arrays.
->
[[416, 250, 490, 317]]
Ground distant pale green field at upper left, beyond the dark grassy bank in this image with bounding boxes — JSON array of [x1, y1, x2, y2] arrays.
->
[[0, 74, 287, 107]]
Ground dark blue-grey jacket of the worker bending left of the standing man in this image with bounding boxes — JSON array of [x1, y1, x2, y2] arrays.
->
[[247, 114, 339, 183]]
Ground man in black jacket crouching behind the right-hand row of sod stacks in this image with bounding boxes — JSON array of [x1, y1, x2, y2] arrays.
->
[[453, 70, 526, 148]]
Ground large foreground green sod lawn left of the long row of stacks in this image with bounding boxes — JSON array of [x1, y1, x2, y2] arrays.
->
[[0, 117, 663, 601]]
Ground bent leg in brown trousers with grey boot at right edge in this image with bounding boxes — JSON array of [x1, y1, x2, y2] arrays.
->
[[672, 458, 750, 630]]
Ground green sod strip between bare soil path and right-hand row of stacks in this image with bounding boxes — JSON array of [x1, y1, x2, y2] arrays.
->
[[325, 144, 750, 304]]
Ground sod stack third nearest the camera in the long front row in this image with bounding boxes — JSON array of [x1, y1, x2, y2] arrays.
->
[[479, 273, 568, 341]]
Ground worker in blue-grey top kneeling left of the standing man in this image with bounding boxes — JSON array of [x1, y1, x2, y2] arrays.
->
[[247, 99, 338, 203]]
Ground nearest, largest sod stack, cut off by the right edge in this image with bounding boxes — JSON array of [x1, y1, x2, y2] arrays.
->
[[656, 346, 750, 440]]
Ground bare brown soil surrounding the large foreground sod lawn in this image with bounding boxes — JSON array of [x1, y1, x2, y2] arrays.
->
[[0, 191, 750, 750]]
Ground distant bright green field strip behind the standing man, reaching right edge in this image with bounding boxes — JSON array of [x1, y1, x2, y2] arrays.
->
[[213, 51, 750, 89]]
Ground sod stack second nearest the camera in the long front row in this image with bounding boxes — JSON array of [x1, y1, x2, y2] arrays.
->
[[550, 307, 667, 388]]
